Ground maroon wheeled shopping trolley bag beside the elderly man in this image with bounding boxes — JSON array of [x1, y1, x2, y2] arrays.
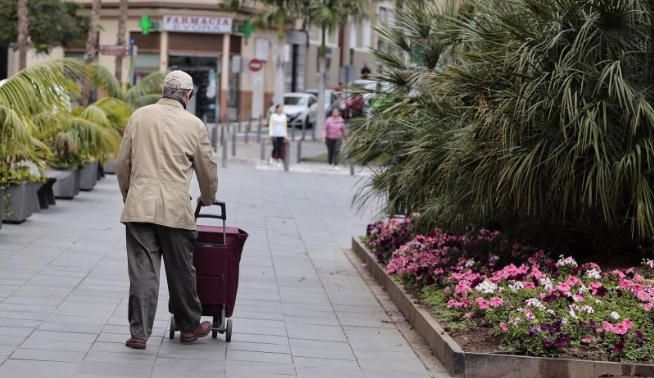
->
[[169, 201, 248, 342]]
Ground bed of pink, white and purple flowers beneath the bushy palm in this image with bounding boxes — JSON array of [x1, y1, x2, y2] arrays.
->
[[365, 219, 654, 362]]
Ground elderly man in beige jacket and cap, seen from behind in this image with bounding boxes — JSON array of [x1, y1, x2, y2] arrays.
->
[[116, 71, 218, 349]]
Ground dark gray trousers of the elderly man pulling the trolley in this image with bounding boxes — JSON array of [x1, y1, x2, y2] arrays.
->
[[126, 223, 202, 340]]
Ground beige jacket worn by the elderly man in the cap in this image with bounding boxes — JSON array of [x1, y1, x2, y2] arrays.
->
[[116, 98, 218, 230]]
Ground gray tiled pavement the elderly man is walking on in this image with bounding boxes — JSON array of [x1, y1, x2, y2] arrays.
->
[[0, 164, 447, 378]]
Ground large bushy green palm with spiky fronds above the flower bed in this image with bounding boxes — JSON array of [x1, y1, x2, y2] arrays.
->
[[350, 0, 654, 252]]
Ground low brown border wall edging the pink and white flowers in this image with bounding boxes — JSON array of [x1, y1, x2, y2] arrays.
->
[[352, 238, 654, 378]]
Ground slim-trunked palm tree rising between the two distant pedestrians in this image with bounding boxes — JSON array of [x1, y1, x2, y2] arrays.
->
[[309, 0, 374, 135]]
